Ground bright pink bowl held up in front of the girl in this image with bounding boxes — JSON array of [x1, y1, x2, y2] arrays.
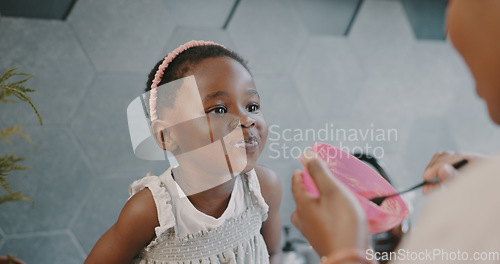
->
[[301, 143, 409, 234]]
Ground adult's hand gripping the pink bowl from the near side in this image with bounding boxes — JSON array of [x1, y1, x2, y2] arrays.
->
[[292, 153, 369, 256]]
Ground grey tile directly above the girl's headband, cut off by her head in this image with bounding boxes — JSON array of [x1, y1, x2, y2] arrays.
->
[[163, 27, 234, 56]]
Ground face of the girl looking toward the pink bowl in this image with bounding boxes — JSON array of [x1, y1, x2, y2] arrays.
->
[[162, 57, 268, 172]]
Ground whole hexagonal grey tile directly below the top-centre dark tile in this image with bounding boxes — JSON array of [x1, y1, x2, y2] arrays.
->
[[293, 37, 365, 120]]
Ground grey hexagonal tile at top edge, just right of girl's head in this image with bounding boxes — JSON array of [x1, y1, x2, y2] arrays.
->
[[228, 0, 307, 76]]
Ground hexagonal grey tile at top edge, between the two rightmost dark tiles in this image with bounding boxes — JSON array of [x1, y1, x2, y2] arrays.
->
[[348, 1, 415, 77]]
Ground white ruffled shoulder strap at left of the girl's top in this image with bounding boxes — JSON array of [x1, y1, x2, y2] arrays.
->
[[129, 173, 175, 247]]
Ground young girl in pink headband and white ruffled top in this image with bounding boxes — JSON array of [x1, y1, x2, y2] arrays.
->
[[85, 41, 281, 264]]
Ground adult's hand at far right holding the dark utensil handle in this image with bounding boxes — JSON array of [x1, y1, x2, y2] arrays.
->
[[422, 151, 487, 194]]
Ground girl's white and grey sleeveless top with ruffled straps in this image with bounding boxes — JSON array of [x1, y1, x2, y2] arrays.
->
[[129, 168, 269, 263]]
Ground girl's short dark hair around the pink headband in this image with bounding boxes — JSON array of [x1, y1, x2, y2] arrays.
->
[[145, 45, 250, 93]]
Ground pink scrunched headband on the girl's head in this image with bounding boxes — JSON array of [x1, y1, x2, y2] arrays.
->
[[149, 40, 226, 122]]
